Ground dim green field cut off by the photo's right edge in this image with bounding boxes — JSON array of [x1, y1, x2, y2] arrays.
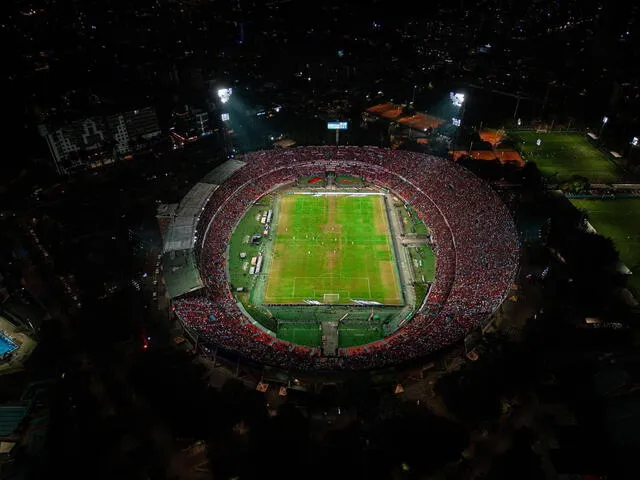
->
[[571, 198, 640, 290]]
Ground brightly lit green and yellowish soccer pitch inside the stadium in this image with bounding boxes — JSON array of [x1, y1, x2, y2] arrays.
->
[[263, 194, 403, 305]]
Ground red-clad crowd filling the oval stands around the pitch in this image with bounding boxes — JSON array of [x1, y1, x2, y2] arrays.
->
[[174, 147, 519, 370]]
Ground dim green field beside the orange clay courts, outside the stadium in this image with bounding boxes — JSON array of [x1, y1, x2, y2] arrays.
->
[[511, 131, 624, 183]]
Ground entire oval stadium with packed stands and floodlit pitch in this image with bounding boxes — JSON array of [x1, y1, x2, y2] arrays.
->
[[162, 146, 519, 371]]
